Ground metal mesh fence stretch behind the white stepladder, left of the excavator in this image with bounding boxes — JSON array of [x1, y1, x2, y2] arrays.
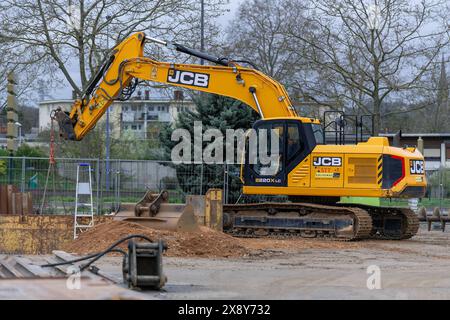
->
[[0, 157, 232, 214]]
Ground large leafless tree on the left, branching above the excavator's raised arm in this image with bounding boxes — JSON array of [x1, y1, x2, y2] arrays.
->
[[0, 0, 229, 99]]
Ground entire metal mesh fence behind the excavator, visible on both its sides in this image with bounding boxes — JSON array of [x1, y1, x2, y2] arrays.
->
[[0, 157, 450, 214]]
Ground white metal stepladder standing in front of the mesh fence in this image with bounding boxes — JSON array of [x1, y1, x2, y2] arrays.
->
[[73, 163, 94, 239]]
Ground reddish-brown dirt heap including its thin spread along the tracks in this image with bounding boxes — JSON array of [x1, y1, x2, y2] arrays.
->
[[62, 221, 377, 258]]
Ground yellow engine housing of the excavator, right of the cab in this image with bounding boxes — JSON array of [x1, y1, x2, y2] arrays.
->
[[243, 137, 427, 198]]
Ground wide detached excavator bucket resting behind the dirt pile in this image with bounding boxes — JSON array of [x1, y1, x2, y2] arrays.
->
[[115, 191, 199, 232]]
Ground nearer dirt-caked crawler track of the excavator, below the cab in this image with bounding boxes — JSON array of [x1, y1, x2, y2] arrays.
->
[[224, 202, 372, 241]]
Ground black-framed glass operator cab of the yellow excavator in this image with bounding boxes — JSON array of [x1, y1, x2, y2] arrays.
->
[[243, 119, 323, 187]]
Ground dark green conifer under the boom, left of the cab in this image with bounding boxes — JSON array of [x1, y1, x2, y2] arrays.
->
[[161, 94, 259, 201]]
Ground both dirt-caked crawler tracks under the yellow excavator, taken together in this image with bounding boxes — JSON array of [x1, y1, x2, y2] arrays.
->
[[223, 202, 419, 241]]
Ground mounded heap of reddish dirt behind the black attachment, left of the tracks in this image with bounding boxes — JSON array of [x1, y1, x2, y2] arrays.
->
[[62, 221, 251, 257]]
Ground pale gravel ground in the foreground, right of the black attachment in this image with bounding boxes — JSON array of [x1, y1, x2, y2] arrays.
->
[[0, 225, 450, 300]]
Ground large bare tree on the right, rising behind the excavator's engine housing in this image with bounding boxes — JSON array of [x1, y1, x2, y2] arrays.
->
[[289, 0, 449, 133]]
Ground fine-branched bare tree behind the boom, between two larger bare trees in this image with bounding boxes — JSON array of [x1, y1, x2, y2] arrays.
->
[[226, 0, 304, 86]]
